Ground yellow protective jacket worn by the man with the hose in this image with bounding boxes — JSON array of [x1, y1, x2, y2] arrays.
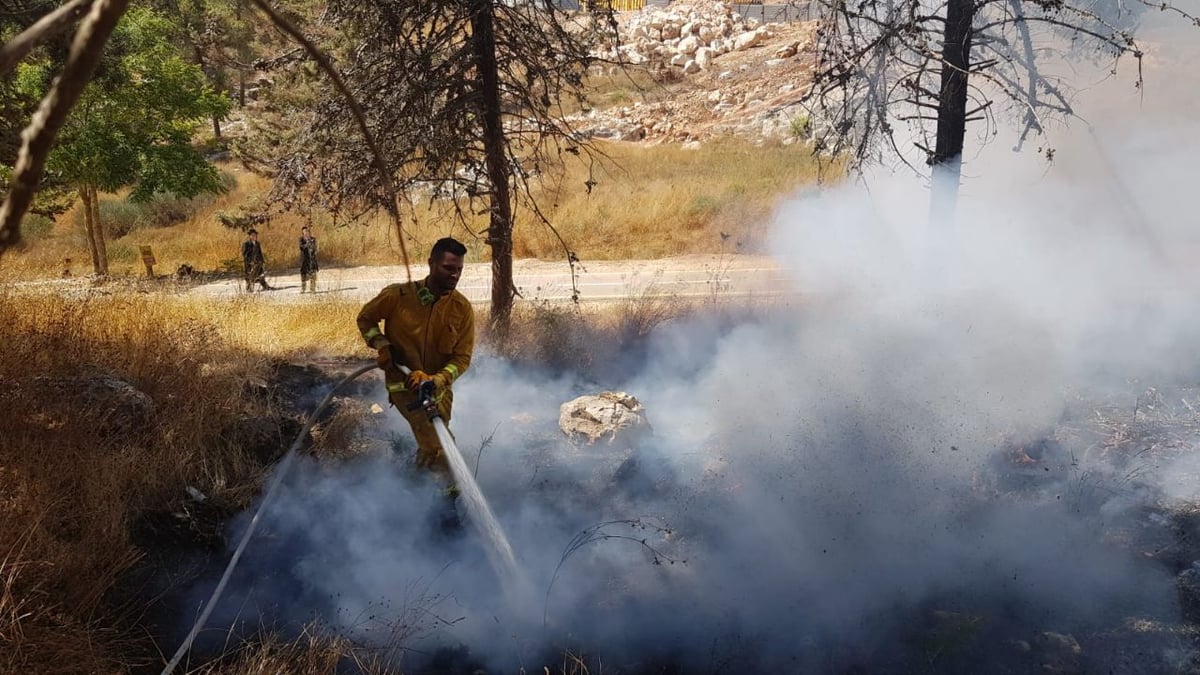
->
[[358, 279, 475, 393]]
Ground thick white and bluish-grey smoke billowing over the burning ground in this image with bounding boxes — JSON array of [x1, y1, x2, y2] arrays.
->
[[180, 15, 1200, 671]]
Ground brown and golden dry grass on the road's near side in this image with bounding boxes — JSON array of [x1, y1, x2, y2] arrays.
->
[[0, 285, 739, 673]]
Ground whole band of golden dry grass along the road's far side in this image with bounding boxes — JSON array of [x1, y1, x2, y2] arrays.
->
[[0, 139, 817, 280]]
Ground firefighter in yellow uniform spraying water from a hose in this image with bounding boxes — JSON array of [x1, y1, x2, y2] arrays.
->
[[358, 237, 475, 473]]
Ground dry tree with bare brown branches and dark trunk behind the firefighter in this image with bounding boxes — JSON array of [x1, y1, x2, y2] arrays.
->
[[242, 0, 611, 323]]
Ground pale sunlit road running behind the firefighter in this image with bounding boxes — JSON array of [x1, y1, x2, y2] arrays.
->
[[192, 256, 792, 304]]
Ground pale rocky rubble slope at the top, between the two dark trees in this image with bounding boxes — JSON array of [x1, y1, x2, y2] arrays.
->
[[571, 0, 817, 142]]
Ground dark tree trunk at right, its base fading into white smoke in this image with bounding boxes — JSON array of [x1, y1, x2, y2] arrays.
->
[[930, 0, 976, 225]]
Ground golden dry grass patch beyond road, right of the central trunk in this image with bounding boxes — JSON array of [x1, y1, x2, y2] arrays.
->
[[514, 139, 818, 259]]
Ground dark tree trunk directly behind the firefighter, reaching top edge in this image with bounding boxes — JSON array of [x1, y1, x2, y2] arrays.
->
[[470, 0, 516, 331]]
